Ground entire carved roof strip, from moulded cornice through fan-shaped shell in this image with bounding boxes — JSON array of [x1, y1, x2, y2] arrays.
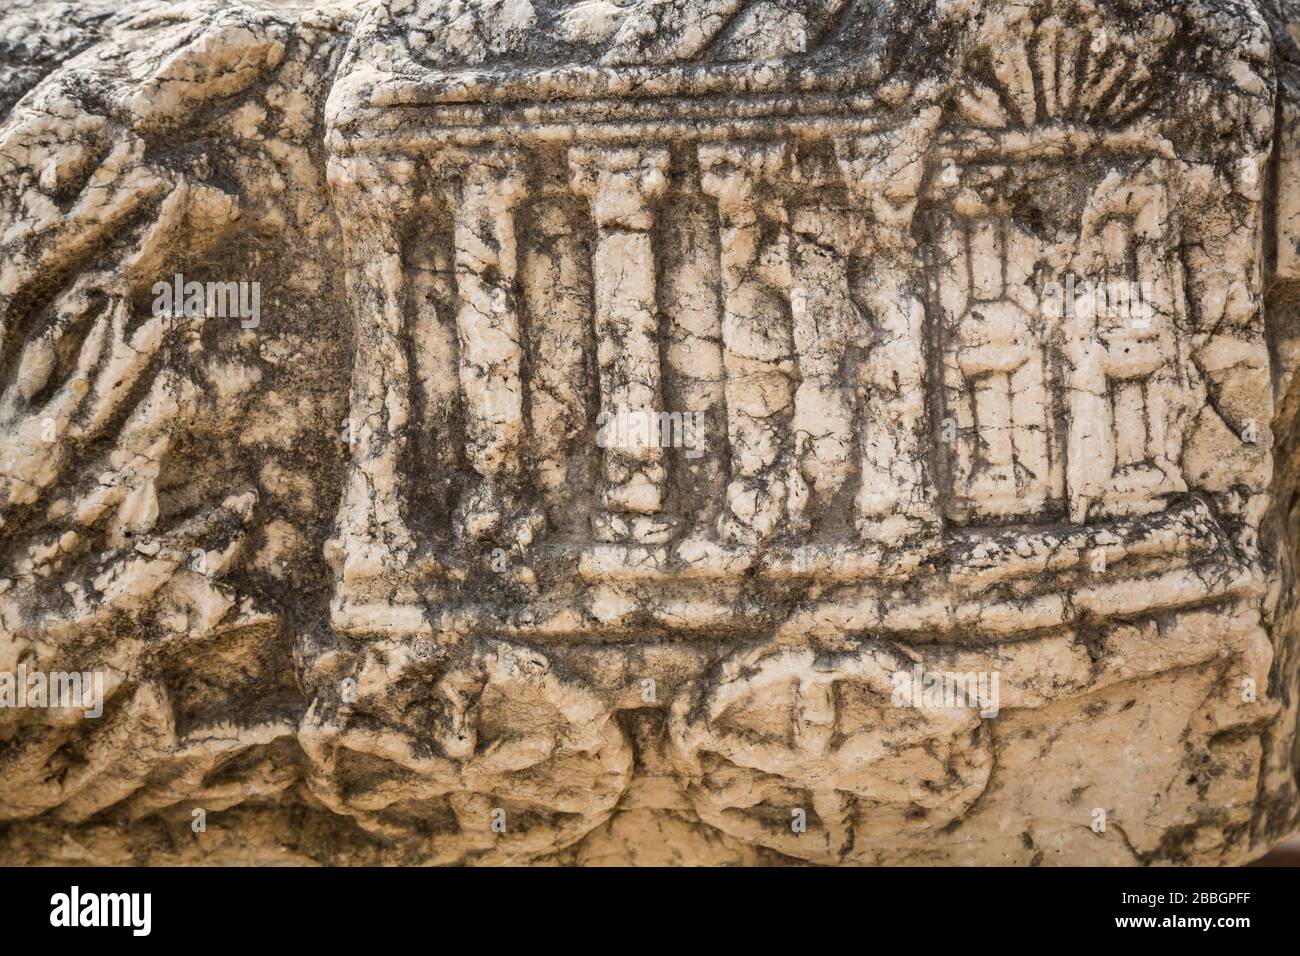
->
[[328, 0, 1273, 166]]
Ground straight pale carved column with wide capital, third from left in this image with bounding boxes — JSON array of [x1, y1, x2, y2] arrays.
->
[[569, 147, 668, 541]]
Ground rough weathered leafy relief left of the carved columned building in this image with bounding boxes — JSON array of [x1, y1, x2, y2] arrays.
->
[[0, 10, 298, 842]]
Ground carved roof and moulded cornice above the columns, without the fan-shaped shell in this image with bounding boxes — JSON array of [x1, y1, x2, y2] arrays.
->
[[329, 0, 950, 143]]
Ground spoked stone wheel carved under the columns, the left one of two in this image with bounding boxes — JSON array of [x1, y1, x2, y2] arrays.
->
[[298, 641, 632, 864]]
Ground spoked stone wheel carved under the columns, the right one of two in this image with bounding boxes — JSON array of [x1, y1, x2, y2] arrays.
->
[[670, 646, 993, 864]]
